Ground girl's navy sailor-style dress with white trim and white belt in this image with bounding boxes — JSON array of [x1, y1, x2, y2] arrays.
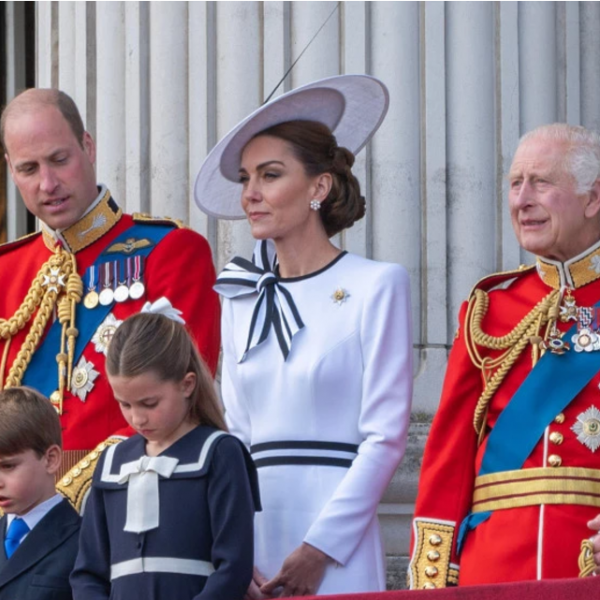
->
[[71, 426, 260, 600]]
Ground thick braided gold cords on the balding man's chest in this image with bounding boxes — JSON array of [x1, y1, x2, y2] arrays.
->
[[0, 247, 83, 414]]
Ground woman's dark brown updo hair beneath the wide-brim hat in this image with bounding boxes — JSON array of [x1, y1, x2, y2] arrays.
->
[[254, 121, 366, 237]]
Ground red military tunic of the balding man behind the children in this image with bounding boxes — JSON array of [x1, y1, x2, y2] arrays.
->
[[0, 185, 220, 466]]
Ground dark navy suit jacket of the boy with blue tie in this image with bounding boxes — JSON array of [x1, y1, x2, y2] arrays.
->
[[0, 500, 81, 600]]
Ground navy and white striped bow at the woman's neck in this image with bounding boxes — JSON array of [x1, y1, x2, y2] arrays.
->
[[214, 240, 304, 362]]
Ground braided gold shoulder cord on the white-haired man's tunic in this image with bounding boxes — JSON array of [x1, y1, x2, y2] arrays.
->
[[464, 289, 561, 443]]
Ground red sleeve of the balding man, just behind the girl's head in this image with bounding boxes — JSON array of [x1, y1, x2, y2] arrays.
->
[[145, 229, 221, 374]]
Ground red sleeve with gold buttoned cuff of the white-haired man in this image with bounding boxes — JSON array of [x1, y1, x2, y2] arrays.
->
[[409, 303, 483, 589]]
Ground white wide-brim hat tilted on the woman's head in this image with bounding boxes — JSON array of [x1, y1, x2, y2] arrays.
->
[[194, 75, 389, 219]]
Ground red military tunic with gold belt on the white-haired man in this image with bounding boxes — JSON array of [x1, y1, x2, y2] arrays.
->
[[409, 239, 600, 588]]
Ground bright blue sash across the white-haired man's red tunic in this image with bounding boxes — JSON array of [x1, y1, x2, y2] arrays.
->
[[457, 302, 600, 551]]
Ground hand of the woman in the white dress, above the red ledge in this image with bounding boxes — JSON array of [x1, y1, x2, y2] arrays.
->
[[260, 542, 333, 598]]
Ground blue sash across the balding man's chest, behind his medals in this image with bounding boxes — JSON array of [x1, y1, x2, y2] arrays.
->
[[23, 223, 174, 396]]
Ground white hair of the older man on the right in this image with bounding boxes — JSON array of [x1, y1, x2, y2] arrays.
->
[[519, 123, 600, 194]]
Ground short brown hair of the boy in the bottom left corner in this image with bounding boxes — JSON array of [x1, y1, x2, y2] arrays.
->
[[0, 387, 62, 457]]
